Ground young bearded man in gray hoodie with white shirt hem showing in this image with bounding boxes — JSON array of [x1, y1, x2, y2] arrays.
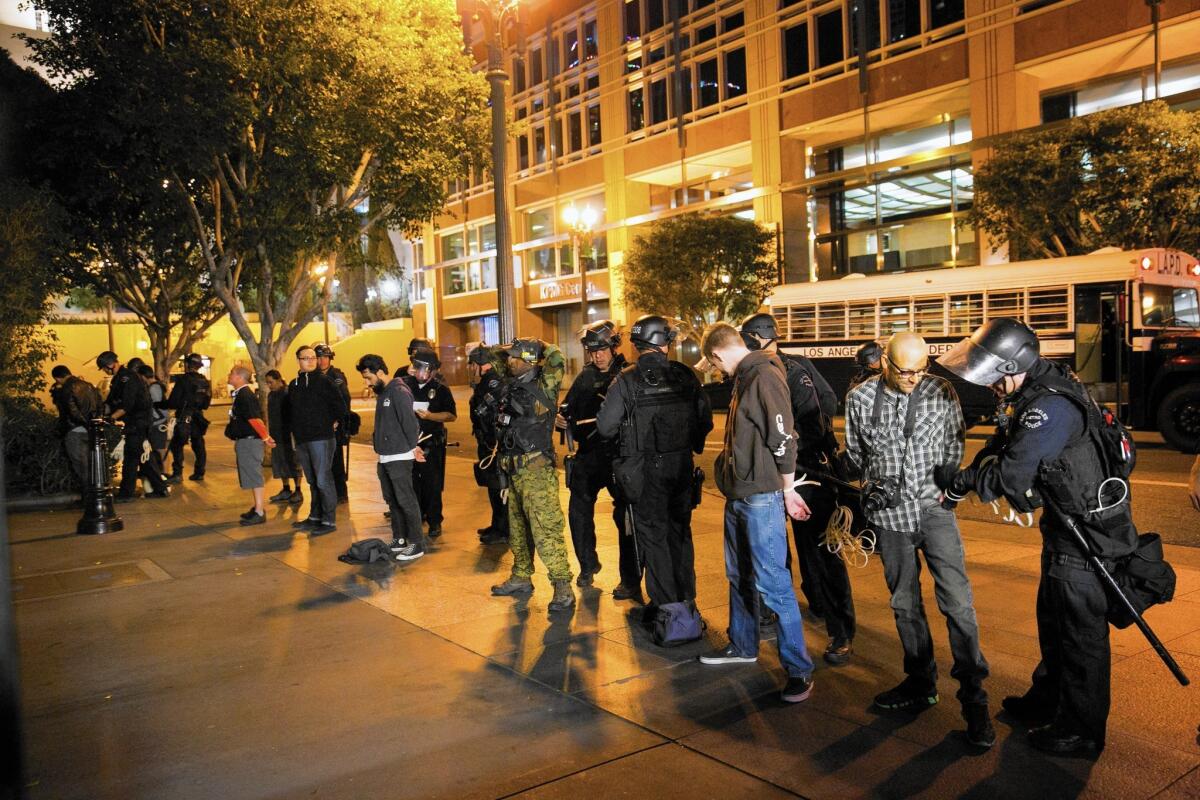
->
[[355, 354, 425, 561]]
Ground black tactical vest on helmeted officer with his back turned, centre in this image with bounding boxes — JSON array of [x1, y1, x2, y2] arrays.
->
[[620, 361, 700, 456]]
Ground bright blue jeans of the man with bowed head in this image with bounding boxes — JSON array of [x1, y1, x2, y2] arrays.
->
[[725, 492, 812, 679]]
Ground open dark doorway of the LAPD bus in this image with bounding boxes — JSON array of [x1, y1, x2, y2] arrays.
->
[[1074, 283, 1129, 405]]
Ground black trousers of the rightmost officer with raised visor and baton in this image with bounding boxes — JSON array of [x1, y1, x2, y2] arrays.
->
[[1028, 551, 1112, 746]]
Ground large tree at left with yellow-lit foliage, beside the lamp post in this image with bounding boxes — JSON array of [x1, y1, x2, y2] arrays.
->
[[30, 0, 487, 383]]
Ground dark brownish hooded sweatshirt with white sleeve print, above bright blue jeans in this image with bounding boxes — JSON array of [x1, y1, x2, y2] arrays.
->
[[715, 350, 796, 500]]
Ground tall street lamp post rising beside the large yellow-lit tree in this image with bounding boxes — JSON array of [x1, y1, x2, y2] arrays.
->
[[476, 0, 518, 342]]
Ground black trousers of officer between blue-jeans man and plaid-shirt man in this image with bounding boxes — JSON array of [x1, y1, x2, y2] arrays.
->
[[792, 487, 856, 639]]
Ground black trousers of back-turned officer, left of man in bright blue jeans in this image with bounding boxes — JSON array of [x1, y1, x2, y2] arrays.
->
[[632, 452, 696, 606]]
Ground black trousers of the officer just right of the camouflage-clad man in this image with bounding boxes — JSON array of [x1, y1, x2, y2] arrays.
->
[[566, 449, 642, 587]]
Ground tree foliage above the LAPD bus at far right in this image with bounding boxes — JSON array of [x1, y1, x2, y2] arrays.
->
[[966, 102, 1200, 258]]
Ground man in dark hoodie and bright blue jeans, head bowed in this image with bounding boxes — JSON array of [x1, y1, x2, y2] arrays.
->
[[700, 323, 812, 703]]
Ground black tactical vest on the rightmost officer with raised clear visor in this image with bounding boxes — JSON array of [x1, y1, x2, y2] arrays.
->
[[1009, 365, 1138, 558]]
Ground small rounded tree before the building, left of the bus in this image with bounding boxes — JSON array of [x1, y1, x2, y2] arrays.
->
[[624, 213, 779, 330]]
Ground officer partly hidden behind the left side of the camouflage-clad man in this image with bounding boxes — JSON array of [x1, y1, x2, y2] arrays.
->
[[467, 342, 509, 545]]
